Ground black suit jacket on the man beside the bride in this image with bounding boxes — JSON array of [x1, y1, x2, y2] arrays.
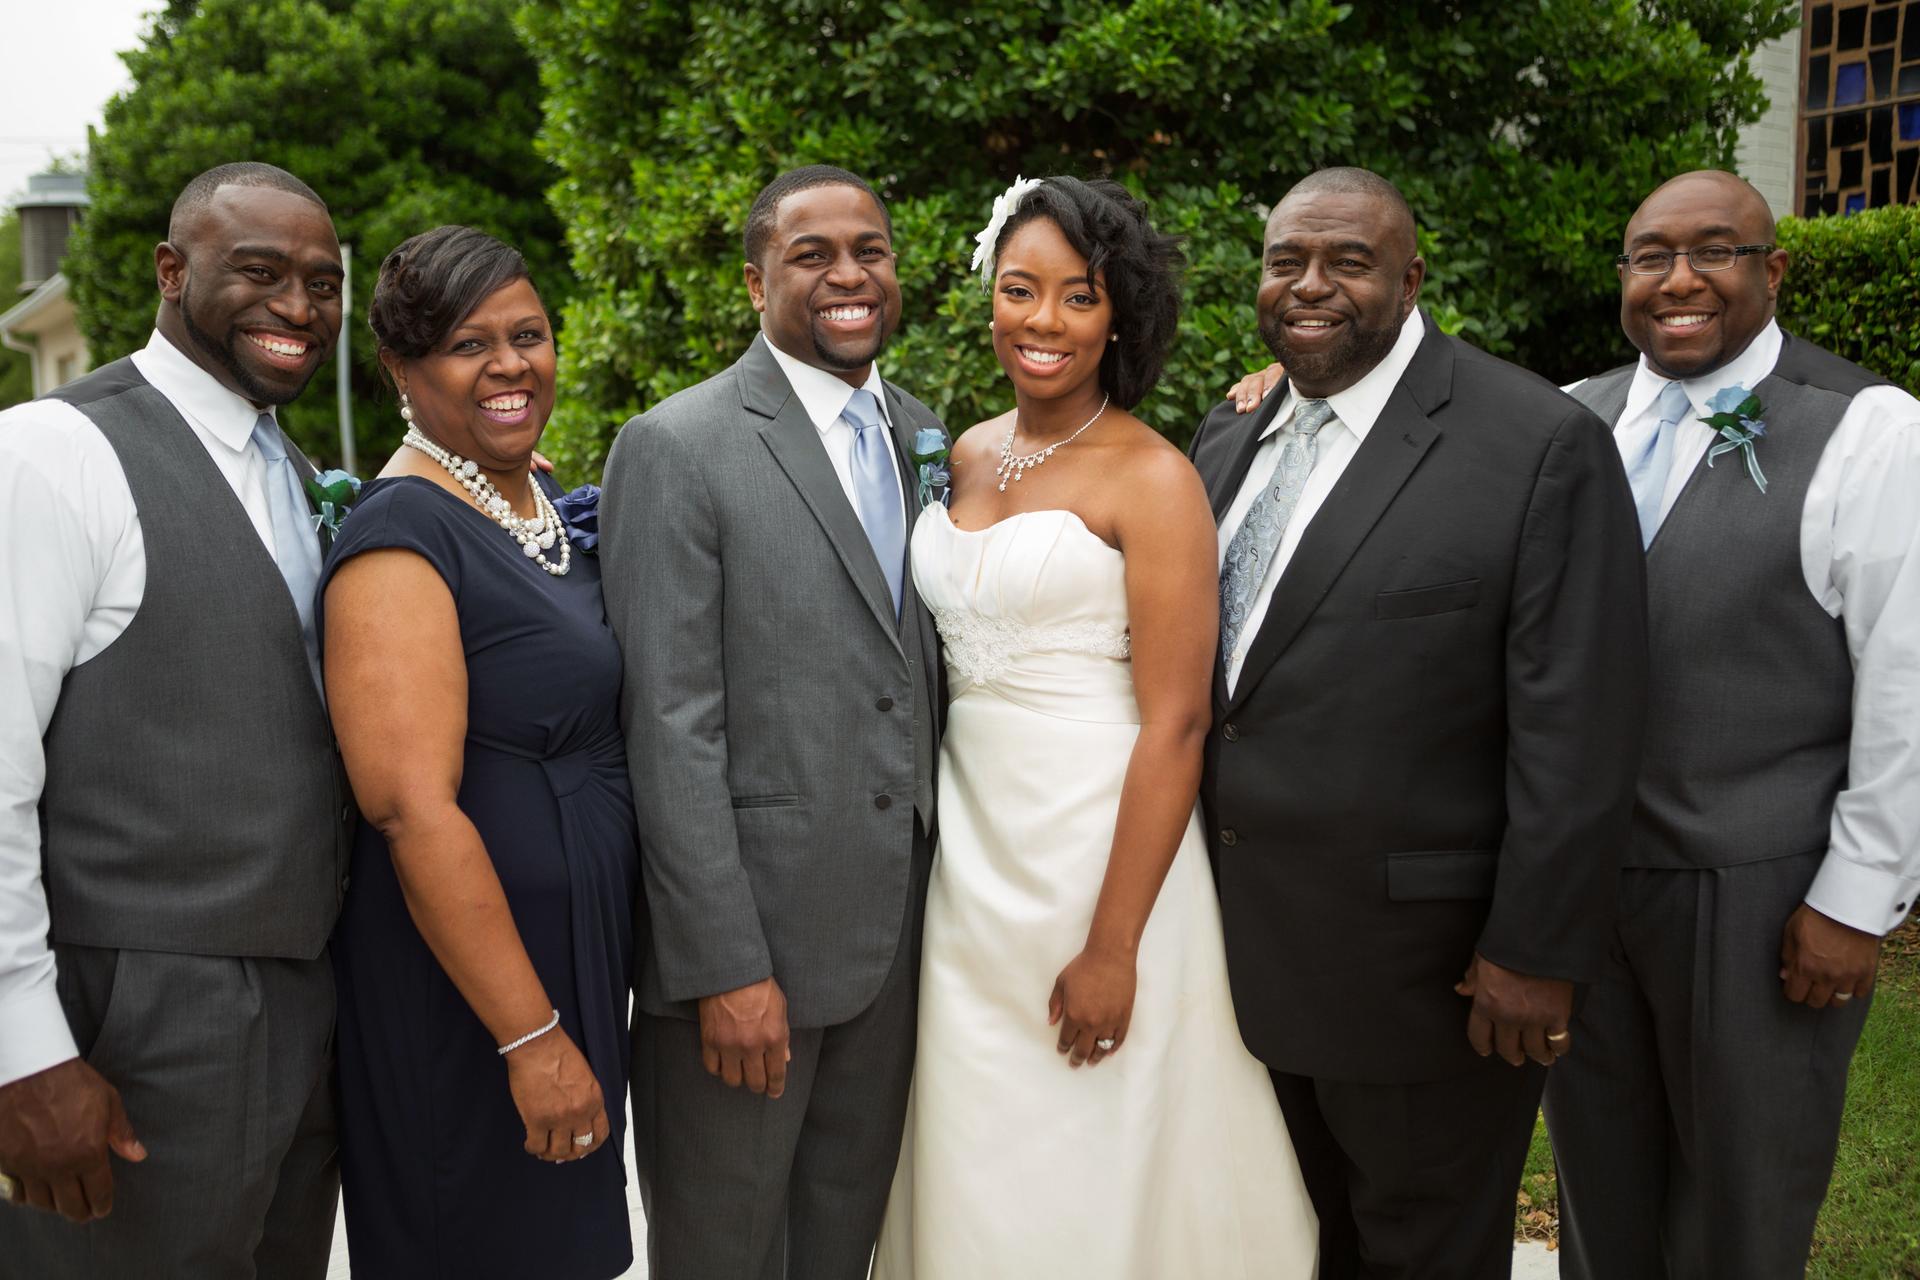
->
[[1192, 320, 1645, 1082]]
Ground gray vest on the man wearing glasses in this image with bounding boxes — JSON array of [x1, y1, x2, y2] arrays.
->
[[1572, 338, 1884, 869]]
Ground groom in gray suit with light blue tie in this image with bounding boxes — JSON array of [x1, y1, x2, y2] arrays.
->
[[601, 165, 939, 1280]]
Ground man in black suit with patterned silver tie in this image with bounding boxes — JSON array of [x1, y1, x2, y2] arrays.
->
[[1192, 169, 1645, 1280]]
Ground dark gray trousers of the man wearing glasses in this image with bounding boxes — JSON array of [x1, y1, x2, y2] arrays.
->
[[1546, 850, 1868, 1280]]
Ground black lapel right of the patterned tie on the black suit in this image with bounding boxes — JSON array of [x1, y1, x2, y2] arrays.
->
[[1215, 320, 1453, 710]]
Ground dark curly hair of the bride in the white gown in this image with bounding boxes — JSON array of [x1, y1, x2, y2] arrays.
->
[[995, 178, 1185, 409]]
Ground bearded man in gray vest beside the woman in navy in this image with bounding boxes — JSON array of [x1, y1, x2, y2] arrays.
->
[[0, 163, 349, 1280]]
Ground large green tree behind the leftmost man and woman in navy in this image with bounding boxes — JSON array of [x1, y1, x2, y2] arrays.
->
[[65, 0, 572, 470]]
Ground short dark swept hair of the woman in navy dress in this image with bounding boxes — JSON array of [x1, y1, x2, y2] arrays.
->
[[367, 226, 540, 361]]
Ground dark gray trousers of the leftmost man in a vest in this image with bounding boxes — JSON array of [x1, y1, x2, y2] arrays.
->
[[0, 946, 340, 1280]]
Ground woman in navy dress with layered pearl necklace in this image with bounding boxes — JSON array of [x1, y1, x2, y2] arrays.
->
[[321, 226, 637, 1280]]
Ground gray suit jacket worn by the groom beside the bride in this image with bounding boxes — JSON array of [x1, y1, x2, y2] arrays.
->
[[601, 338, 939, 1027]]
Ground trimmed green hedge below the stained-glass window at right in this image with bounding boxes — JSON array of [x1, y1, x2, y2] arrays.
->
[[1778, 205, 1920, 395]]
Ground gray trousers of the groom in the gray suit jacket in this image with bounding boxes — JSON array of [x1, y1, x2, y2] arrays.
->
[[634, 839, 931, 1280]]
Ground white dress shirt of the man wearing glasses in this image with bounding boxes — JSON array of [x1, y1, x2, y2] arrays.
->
[[1574, 320, 1920, 935]]
